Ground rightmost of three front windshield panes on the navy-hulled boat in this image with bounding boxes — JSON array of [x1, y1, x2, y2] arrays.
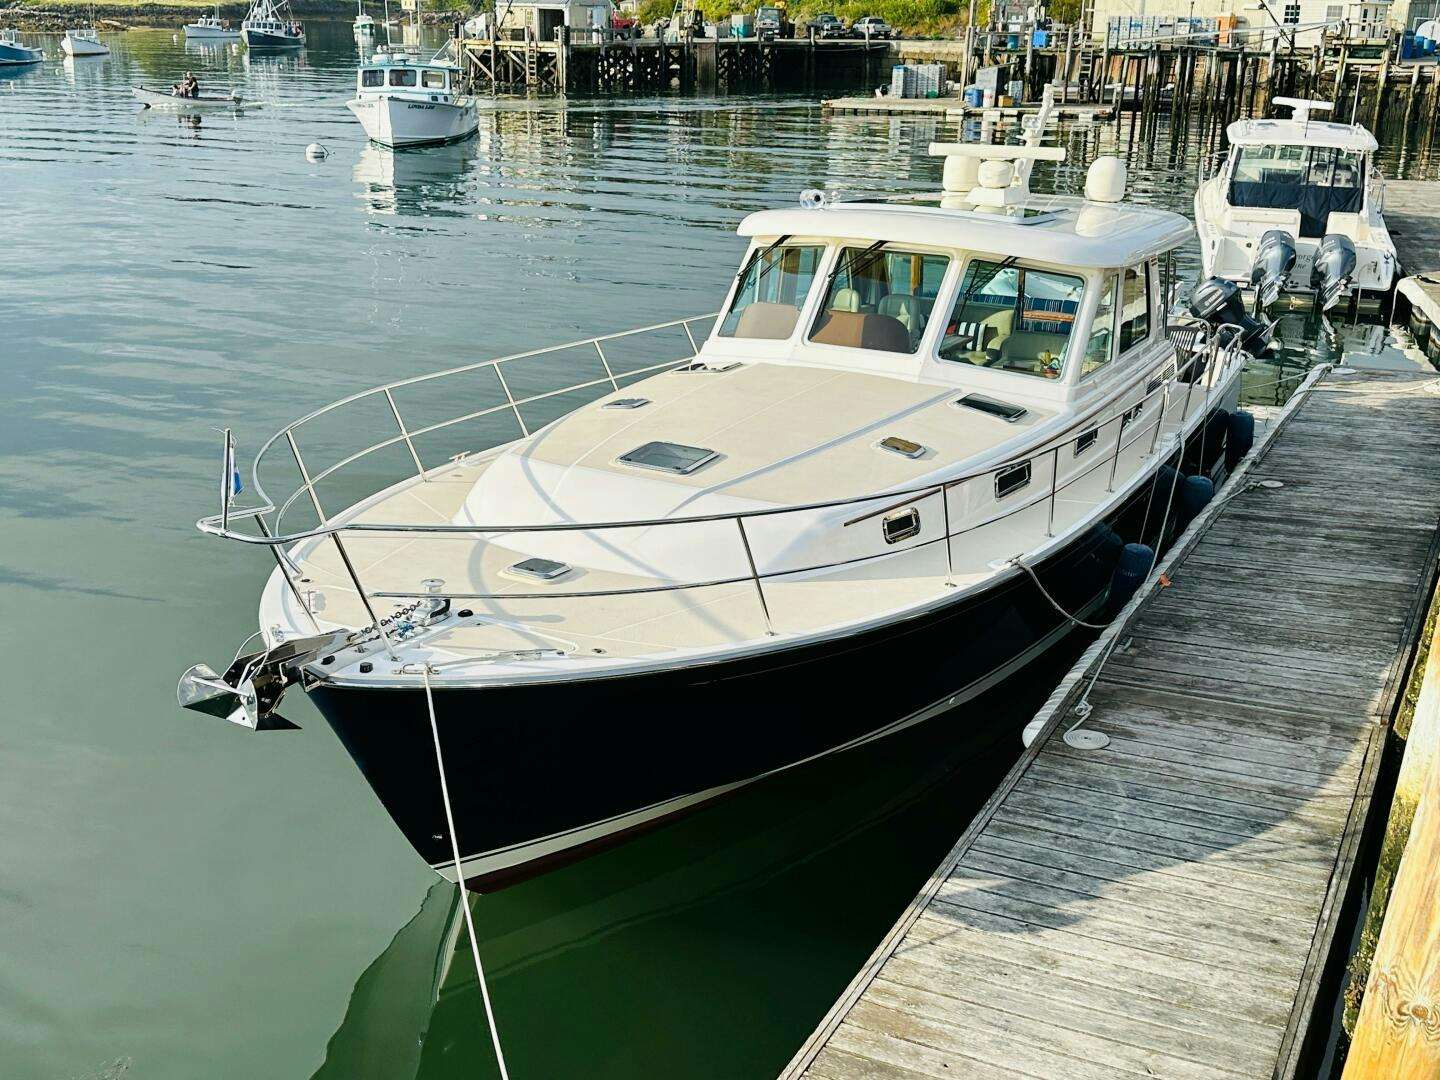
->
[[940, 259, 1084, 379]]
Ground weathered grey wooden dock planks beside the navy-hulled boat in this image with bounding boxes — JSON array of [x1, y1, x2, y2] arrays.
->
[[783, 372, 1440, 1080]]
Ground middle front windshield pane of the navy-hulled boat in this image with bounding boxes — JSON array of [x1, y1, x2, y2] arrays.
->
[[809, 248, 950, 353]]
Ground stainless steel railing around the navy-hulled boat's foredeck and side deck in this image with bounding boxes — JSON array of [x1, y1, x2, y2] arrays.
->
[[196, 315, 1244, 665]]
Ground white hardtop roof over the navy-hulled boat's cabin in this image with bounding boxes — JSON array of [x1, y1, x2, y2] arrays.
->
[[739, 193, 1194, 269]]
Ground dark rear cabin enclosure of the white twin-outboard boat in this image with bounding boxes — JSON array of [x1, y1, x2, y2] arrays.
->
[[1230, 145, 1365, 236]]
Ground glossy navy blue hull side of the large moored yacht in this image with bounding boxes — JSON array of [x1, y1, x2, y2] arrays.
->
[[311, 411, 1224, 887]]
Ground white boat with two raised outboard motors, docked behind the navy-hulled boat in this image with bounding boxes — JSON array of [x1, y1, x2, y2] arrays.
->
[[1195, 98, 1397, 311]]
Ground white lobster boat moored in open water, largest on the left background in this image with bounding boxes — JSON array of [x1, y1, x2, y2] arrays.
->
[[346, 48, 480, 148]]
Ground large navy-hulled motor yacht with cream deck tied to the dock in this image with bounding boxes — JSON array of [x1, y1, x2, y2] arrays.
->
[[180, 131, 1261, 887]]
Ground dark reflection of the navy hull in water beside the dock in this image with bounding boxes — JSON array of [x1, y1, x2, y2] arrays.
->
[[315, 679, 1054, 1080]]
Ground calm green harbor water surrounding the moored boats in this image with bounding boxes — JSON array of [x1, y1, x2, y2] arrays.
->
[[0, 24, 1431, 1080]]
